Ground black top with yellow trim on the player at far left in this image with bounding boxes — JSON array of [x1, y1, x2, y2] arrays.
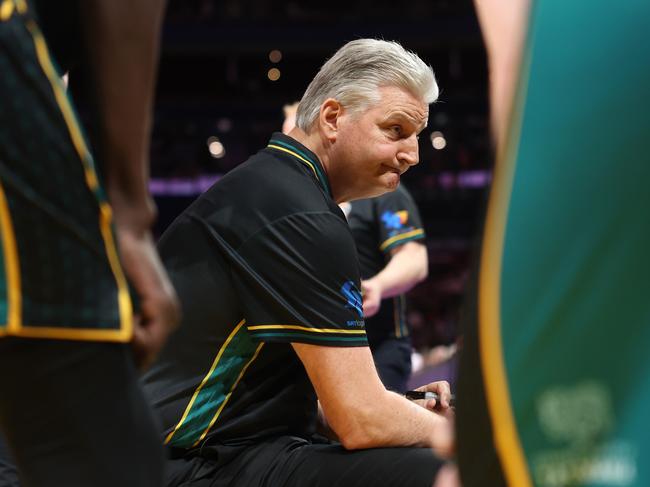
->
[[0, 2, 133, 343]]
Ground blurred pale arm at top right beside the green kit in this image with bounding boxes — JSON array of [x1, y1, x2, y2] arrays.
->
[[474, 0, 530, 147]]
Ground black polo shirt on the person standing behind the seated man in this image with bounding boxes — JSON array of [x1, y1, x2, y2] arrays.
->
[[344, 184, 425, 347]]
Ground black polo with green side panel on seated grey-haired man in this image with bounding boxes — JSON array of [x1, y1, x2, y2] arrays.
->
[[144, 133, 367, 449]]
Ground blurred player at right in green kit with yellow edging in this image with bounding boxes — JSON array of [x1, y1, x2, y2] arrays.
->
[[457, 0, 650, 487]]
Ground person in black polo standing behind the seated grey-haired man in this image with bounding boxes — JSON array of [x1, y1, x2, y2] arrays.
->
[[341, 184, 429, 392]]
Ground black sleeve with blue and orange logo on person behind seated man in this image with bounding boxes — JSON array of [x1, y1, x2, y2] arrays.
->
[[375, 186, 425, 253]]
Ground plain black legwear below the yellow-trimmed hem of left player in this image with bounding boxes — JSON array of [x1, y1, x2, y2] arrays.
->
[[0, 337, 163, 487]]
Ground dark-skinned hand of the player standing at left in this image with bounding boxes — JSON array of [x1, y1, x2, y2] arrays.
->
[[116, 225, 180, 369]]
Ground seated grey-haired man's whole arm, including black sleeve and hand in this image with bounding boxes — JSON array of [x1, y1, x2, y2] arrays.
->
[[233, 211, 453, 454]]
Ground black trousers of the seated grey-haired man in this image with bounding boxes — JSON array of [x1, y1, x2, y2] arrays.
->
[[165, 436, 443, 487]]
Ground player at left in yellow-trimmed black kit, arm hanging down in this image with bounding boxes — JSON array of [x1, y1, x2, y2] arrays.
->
[[0, 0, 178, 487]]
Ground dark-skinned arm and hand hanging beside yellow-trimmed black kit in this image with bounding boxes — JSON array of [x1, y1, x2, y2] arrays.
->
[[79, 0, 179, 362]]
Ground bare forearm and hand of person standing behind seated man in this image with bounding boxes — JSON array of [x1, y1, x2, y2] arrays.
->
[[361, 241, 429, 318]]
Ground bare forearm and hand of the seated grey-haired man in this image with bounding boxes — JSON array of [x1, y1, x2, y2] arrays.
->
[[292, 343, 454, 456]]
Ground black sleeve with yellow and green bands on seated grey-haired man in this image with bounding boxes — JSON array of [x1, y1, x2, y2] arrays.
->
[[233, 212, 368, 346]]
